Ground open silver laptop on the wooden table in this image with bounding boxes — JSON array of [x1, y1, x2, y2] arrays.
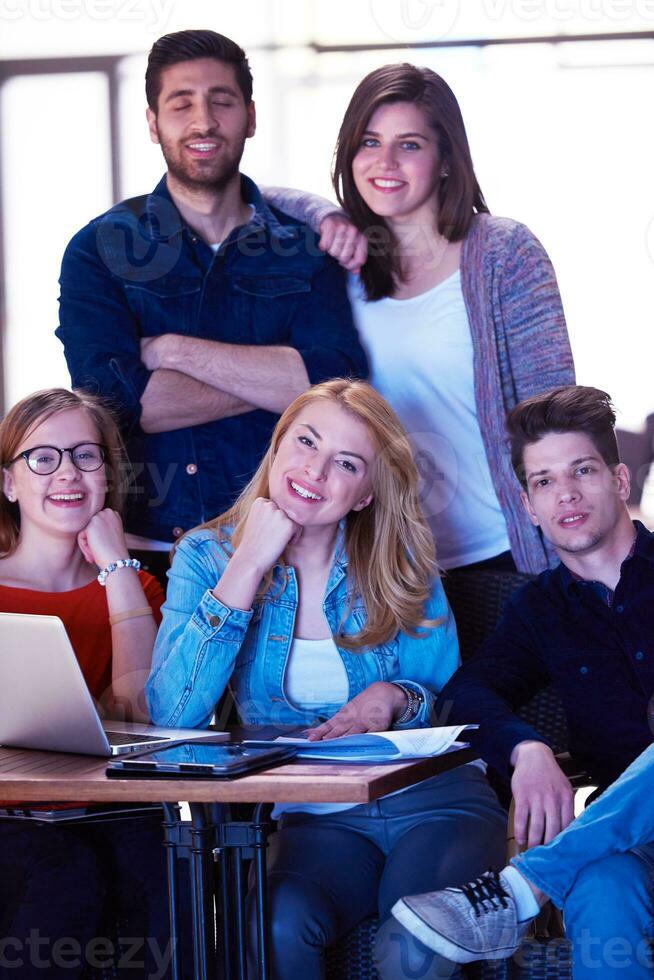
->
[[0, 613, 228, 756]]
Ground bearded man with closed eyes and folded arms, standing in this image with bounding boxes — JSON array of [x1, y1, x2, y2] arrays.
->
[[57, 30, 366, 565]]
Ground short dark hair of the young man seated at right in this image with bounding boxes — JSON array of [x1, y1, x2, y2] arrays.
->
[[506, 385, 620, 490]]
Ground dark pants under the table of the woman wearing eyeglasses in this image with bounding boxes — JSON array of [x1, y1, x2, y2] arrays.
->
[[0, 811, 179, 980]]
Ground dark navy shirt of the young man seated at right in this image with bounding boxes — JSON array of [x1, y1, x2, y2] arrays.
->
[[436, 521, 654, 786]]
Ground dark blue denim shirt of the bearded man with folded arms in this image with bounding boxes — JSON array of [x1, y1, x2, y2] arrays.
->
[[56, 177, 366, 541]]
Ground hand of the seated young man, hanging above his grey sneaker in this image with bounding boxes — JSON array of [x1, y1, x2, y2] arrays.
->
[[511, 742, 574, 847]]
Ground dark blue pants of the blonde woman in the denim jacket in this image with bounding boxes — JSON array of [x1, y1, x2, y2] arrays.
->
[[251, 766, 506, 980]]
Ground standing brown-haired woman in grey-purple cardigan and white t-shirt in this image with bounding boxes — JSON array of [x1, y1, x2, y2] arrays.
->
[[266, 64, 574, 573]]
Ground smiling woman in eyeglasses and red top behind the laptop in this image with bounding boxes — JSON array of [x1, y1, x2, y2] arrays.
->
[[0, 389, 168, 980]]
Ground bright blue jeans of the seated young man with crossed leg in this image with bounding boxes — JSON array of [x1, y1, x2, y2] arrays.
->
[[512, 745, 654, 980]]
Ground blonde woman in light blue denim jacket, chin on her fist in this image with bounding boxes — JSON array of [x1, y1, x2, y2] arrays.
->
[[147, 380, 506, 980]]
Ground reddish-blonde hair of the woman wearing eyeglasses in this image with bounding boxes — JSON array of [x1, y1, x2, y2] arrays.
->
[[0, 388, 129, 558]]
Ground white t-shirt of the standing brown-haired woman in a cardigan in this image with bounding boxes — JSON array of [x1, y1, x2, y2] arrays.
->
[[348, 270, 510, 569]]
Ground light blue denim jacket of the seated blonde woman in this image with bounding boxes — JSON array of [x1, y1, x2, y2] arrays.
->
[[146, 529, 459, 728]]
